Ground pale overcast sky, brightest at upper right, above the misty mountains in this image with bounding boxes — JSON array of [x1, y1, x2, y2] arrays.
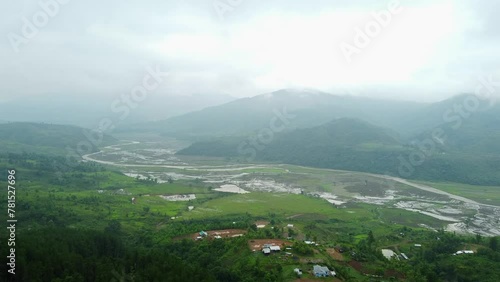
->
[[0, 0, 500, 101]]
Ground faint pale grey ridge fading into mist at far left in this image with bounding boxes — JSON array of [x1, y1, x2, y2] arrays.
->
[[0, 92, 234, 128]]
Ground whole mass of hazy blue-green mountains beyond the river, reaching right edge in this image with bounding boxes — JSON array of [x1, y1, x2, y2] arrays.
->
[[0, 89, 500, 184]]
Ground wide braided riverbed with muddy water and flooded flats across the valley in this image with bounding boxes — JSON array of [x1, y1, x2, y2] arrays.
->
[[84, 142, 500, 236]]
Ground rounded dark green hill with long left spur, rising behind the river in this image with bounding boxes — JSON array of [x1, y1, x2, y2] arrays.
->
[[178, 118, 405, 171]]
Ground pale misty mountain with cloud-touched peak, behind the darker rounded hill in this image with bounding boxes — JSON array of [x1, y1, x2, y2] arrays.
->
[[121, 89, 426, 137]]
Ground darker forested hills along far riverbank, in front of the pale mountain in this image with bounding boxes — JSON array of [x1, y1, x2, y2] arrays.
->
[[178, 119, 500, 185]]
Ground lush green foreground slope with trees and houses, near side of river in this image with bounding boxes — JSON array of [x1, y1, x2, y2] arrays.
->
[[0, 153, 500, 281]]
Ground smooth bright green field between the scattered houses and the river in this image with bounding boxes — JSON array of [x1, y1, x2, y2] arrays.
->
[[184, 193, 443, 236]]
